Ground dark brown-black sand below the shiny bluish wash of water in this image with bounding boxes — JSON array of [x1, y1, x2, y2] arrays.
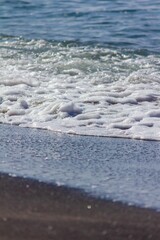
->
[[0, 174, 160, 240]]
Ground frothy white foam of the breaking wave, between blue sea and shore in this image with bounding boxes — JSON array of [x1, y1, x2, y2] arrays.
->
[[0, 39, 160, 140]]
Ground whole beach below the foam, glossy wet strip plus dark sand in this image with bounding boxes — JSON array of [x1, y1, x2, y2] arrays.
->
[[0, 124, 160, 240]]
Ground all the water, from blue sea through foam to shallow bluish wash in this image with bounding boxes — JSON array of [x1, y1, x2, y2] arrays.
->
[[0, 0, 160, 209]]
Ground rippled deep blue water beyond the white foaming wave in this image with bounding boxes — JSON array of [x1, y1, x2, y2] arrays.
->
[[0, 0, 160, 52]]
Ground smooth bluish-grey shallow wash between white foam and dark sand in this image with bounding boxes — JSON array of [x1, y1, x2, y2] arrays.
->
[[0, 125, 160, 210]]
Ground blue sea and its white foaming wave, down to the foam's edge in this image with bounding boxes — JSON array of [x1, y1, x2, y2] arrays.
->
[[0, 0, 160, 140]]
